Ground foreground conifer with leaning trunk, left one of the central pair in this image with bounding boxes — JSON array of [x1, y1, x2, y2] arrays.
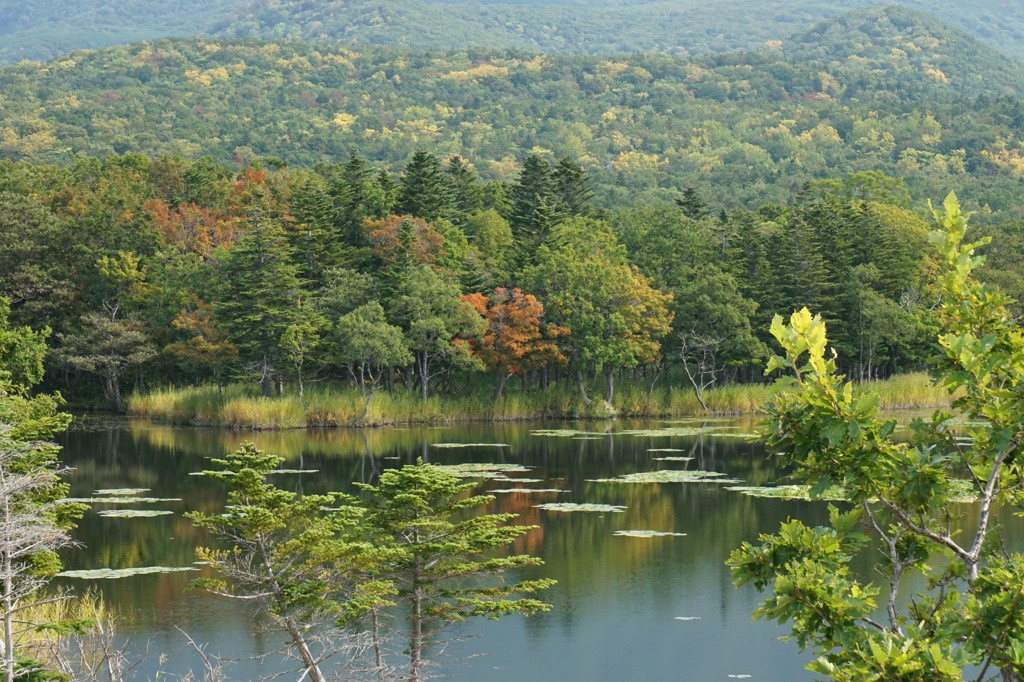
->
[[187, 443, 391, 682]]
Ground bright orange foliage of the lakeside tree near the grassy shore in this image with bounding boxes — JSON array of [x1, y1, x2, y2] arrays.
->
[[462, 287, 569, 375]]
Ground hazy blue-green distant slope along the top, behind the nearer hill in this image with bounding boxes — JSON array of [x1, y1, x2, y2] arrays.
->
[[6, 0, 1024, 63]]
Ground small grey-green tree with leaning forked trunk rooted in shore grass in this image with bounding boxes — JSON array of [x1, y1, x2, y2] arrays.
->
[[331, 301, 414, 422]]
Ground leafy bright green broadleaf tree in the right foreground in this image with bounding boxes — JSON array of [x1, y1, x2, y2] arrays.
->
[[729, 195, 1024, 682]]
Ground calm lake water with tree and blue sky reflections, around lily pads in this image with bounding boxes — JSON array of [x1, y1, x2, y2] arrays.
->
[[56, 422, 826, 682]]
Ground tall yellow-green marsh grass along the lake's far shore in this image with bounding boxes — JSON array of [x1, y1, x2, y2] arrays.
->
[[129, 373, 949, 429]]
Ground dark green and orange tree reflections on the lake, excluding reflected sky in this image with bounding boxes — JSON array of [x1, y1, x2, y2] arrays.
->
[[58, 422, 825, 675]]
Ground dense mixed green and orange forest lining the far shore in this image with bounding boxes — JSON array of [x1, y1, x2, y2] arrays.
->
[[0, 146, 1024, 408]]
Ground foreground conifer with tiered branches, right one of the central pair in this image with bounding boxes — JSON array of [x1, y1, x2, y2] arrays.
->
[[356, 460, 555, 682]]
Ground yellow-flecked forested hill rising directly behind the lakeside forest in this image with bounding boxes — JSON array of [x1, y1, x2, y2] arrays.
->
[[0, 9, 1024, 211]]
